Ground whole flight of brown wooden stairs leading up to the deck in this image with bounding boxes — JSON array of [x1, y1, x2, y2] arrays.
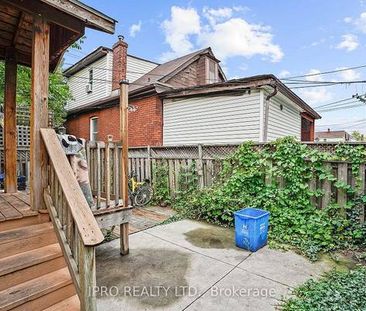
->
[[0, 222, 80, 311]]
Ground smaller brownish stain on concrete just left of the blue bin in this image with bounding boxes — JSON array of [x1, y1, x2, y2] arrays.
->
[[184, 227, 236, 249]]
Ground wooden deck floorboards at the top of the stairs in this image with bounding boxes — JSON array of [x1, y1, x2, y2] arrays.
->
[[0, 192, 38, 222]]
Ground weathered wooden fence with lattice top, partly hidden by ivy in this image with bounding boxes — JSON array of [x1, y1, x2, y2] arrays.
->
[[87, 142, 366, 221]]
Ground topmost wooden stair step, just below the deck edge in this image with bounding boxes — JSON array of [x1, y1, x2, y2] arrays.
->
[[0, 222, 57, 258]]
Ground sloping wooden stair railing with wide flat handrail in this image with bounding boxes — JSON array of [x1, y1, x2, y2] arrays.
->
[[41, 128, 104, 310]]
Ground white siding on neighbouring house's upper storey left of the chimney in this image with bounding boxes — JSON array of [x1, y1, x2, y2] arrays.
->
[[66, 53, 112, 109]]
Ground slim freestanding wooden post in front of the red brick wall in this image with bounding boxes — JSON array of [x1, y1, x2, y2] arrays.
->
[[119, 80, 129, 255]]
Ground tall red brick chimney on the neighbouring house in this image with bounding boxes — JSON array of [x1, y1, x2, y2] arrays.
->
[[112, 36, 128, 91]]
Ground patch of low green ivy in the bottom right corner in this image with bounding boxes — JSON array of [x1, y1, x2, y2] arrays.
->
[[282, 268, 366, 311]]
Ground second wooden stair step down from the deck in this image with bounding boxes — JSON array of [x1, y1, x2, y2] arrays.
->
[[0, 243, 66, 291]]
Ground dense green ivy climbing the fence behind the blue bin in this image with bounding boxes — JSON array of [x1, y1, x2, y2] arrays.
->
[[173, 137, 366, 260]]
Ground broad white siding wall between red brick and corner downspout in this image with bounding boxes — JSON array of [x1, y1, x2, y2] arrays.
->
[[163, 91, 259, 145]]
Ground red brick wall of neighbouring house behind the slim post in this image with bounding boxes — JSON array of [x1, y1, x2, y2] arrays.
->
[[66, 96, 163, 147]]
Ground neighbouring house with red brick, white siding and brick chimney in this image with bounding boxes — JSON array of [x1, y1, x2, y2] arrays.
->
[[66, 37, 320, 146]]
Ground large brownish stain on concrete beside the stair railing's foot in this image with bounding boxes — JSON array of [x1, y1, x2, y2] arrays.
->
[[97, 248, 190, 308]]
